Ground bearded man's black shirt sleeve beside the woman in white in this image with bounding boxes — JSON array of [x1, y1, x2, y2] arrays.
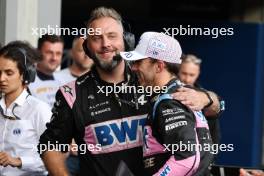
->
[[38, 90, 74, 155]]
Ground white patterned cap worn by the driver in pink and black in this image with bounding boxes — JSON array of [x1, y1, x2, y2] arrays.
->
[[120, 32, 182, 64]]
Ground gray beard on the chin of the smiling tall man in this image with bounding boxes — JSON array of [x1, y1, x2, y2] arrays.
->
[[94, 53, 122, 73]]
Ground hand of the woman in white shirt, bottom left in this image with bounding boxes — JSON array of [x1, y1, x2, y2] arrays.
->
[[0, 152, 22, 167]]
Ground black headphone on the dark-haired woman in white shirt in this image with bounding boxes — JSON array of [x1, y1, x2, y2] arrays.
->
[[18, 48, 36, 84]]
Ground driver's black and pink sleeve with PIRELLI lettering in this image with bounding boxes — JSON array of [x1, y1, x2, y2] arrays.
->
[[153, 100, 200, 176]]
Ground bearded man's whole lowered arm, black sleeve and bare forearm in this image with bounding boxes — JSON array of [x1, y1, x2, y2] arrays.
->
[[38, 90, 75, 176]]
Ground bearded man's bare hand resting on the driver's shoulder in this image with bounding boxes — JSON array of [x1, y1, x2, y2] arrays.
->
[[172, 87, 209, 111]]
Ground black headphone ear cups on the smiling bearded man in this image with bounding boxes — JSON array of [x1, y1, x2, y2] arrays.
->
[[82, 25, 136, 59]]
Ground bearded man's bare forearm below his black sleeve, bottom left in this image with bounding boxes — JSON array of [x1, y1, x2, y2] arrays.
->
[[42, 151, 69, 176]]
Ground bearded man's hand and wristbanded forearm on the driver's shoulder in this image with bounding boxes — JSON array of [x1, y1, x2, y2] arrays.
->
[[172, 87, 221, 117]]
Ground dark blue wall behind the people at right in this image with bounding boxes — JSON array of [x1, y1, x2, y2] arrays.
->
[[177, 24, 264, 167]]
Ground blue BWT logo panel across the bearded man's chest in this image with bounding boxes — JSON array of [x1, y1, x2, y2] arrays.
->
[[84, 115, 146, 153]]
